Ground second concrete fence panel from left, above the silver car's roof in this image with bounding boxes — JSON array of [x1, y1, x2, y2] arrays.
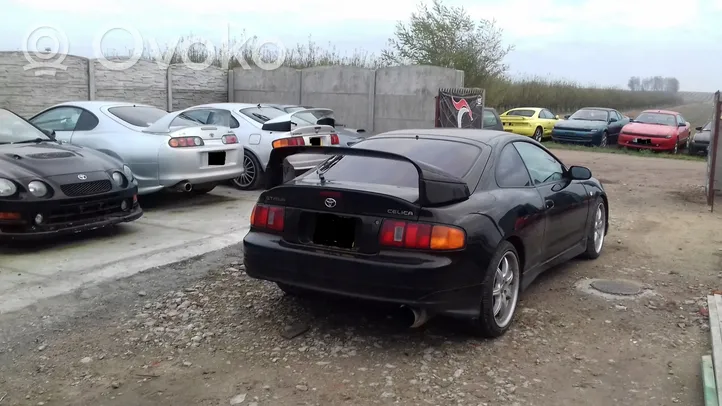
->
[[92, 60, 168, 110]]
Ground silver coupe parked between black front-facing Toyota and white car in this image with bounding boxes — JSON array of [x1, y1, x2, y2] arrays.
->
[[29, 101, 244, 195]]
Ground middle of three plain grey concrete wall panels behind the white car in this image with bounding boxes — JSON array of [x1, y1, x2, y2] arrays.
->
[[301, 66, 375, 130]]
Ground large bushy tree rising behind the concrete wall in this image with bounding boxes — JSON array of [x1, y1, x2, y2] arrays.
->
[[381, 0, 514, 86]]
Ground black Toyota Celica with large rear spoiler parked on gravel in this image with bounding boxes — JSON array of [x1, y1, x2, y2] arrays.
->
[[243, 128, 608, 337]]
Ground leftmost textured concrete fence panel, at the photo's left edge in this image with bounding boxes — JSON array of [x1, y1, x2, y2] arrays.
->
[[0, 52, 89, 118]]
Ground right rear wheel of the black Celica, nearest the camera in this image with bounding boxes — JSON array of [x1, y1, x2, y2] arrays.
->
[[471, 241, 521, 338]]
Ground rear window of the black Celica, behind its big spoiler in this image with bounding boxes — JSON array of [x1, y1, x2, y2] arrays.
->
[[304, 138, 481, 188]]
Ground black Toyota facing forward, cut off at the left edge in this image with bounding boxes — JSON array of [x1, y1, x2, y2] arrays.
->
[[0, 109, 143, 240]]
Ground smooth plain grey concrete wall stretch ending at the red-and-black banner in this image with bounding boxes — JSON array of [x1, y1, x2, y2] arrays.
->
[[232, 66, 464, 133]]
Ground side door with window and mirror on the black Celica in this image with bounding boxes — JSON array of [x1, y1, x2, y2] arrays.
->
[[514, 141, 589, 260]]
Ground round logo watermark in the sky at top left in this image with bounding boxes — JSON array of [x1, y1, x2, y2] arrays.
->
[[23, 25, 69, 76]]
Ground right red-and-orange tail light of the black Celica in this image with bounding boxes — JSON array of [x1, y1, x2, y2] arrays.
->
[[379, 220, 466, 250]]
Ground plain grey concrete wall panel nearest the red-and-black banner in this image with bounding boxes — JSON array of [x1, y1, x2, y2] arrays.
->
[[374, 66, 463, 133]]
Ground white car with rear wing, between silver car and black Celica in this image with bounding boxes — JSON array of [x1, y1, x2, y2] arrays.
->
[[183, 103, 339, 190]]
